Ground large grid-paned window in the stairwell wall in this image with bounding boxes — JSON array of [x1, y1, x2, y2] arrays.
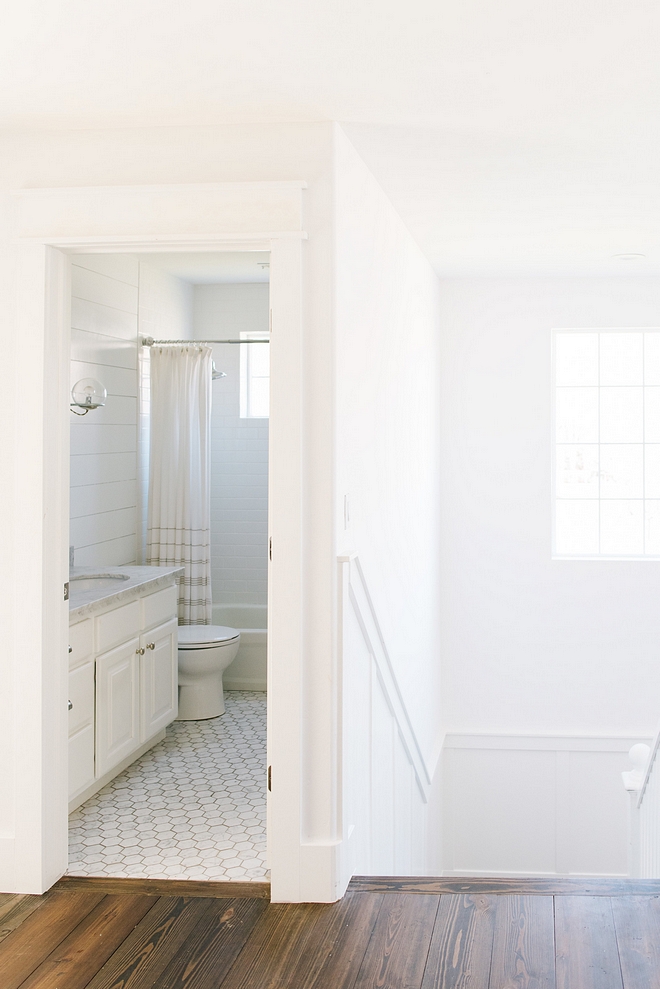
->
[[553, 328, 660, 559]]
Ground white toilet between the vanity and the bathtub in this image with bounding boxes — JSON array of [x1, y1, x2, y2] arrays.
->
[[177, 625, 241, 721]]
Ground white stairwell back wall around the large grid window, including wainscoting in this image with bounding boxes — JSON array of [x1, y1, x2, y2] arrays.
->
[[438, 277, 660, 874]]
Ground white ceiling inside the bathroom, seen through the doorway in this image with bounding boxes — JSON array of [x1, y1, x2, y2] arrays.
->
[[137, 251, 270, 285]]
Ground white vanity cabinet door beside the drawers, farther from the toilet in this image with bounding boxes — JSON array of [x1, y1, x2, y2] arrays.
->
[[96, 638, 140, 778]]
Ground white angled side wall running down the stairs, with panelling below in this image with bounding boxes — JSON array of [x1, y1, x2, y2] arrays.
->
[[335, 132, 442, 874]]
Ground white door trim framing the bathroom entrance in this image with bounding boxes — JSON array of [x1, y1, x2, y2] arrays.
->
[[6, 182, 306, 901]]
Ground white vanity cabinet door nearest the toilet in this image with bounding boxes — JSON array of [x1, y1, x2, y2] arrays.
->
[[140, 618, 179, 742]]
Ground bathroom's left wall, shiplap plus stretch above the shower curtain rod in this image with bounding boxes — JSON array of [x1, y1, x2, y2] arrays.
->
[[70, 254, 192, 566]]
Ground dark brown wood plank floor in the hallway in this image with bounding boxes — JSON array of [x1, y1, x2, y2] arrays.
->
[[0, 877, 660, 989]]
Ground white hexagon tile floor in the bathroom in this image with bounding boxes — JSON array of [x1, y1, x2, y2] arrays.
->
[[68, 690, 268, 881]]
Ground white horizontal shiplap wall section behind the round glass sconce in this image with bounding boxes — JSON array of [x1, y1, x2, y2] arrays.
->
[[70, 254, 139, 566]]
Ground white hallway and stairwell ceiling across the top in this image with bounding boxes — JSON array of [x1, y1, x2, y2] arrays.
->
[[5, 0, 660, 272]]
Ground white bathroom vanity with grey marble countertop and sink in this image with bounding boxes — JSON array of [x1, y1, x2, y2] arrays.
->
[[69, 567, 183, 811]]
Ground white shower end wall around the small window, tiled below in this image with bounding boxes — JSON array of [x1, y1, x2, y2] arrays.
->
[[193, 282, 269, 604]]
